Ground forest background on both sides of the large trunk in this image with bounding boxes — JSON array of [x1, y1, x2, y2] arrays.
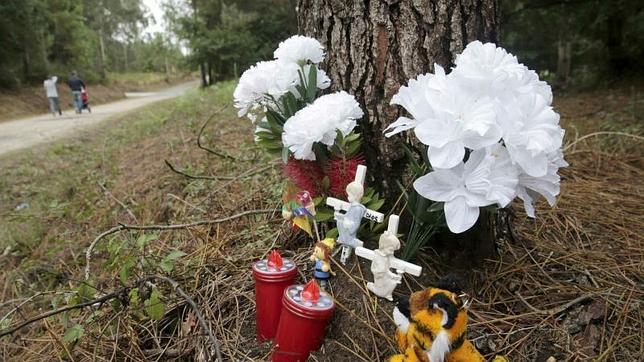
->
[[0, 0, 644, 89]]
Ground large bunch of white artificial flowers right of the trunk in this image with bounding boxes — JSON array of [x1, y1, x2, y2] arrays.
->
[[385, 41, 567, 233]]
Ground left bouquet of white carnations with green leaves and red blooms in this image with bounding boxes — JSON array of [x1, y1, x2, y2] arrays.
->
[[233, 35, 383, 221]]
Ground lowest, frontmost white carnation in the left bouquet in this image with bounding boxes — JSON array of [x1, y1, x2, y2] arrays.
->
[[282, 91, 363, 160]]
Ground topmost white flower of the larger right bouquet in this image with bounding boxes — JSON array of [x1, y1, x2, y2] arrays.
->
[[452, 40, 527, 98]]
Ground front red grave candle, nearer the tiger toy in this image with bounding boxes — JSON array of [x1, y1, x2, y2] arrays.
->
[[272, 279, 335, 362]]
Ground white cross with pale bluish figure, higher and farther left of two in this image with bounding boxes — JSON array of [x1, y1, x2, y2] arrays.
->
[[326, 165, 385, 264]]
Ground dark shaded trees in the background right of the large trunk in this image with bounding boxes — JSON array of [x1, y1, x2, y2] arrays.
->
[[502, 0, 644, 88]]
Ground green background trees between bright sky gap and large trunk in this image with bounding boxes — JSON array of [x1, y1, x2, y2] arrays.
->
[[167, 0, 297, 86]]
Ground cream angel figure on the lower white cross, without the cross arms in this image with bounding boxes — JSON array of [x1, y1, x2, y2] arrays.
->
[[367, 230, 405, 301]]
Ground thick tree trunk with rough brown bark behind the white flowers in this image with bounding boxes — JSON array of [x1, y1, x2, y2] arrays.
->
[[297, 0, 500, 266]]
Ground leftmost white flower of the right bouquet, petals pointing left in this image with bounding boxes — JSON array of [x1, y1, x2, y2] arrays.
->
[[385, 64, 447, 137]]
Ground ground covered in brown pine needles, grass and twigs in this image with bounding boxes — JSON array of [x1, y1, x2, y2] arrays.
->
[[0, 84, 644, 361]]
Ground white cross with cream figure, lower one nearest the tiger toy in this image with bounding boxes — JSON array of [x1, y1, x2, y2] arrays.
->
[[356, 215, 423, 301]]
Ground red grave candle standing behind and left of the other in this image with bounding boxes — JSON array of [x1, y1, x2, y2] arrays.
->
[[253, 250, 297, 341]]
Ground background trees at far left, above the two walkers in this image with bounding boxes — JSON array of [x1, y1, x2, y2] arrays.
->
[[0, 0, 183, 88]]
